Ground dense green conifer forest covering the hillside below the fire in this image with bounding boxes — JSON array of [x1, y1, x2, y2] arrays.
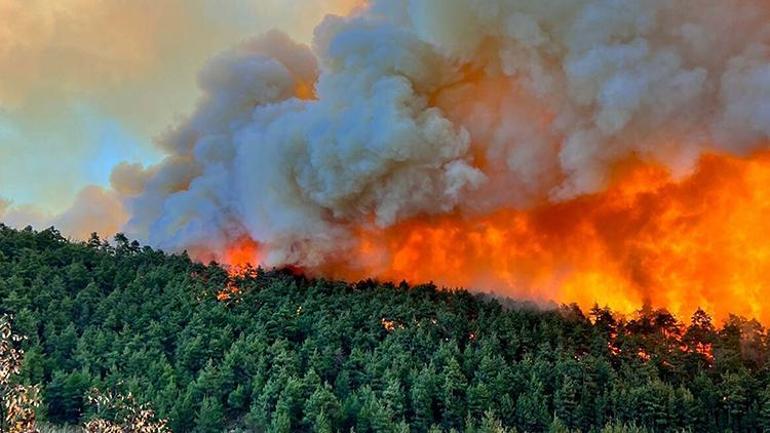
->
[[0, 224, 770, 433]]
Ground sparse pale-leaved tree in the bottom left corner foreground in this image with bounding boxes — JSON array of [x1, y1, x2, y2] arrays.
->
[[0, 315, 40, 433]]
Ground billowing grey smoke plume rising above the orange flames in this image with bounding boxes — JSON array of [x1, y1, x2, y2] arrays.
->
[[113, 0, 770, 266]]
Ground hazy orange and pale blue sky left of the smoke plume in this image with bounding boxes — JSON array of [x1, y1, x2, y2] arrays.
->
[[0, 0, 359, 213]]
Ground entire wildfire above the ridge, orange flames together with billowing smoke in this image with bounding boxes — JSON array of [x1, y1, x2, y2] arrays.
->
[[97, 0, 770, 324]]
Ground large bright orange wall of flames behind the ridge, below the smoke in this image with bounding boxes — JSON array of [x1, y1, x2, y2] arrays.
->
[[308, 153, 770, 323]]
